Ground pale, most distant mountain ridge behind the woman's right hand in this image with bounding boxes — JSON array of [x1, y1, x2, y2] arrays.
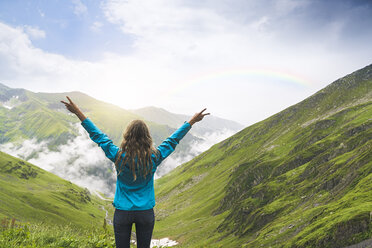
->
[[132, 107, 243, 136]]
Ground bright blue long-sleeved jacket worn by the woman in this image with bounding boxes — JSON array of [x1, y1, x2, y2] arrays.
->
[[81, 118, 191, 210]]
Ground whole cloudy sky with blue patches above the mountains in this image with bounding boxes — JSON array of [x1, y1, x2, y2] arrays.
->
[[0, 0, 372, 125]]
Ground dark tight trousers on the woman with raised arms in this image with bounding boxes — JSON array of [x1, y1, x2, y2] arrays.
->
[[114, 209, 155, 248]]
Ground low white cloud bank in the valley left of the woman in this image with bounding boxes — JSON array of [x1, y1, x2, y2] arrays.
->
[[0, 125, 116, 196]]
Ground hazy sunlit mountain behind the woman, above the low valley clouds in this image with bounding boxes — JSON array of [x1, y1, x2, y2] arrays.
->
[[0, 84, 197, 150]]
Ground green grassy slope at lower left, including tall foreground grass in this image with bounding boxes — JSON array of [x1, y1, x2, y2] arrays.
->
[[0, 152, 120, 248]]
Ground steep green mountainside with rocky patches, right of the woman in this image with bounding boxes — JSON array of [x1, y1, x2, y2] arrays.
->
[[155, 65, 372, 247]]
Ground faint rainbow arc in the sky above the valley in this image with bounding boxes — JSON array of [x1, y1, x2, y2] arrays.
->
[[165, 68, 312, 95]]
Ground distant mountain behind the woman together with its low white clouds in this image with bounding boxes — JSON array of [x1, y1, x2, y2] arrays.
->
[[0, 84, 202, 194]]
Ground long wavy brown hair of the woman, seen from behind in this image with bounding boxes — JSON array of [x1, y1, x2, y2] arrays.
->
[[115, 120, 156, 181]]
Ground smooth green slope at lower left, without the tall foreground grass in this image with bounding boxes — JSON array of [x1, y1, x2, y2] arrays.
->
[[0, 152, 107, 228]]
